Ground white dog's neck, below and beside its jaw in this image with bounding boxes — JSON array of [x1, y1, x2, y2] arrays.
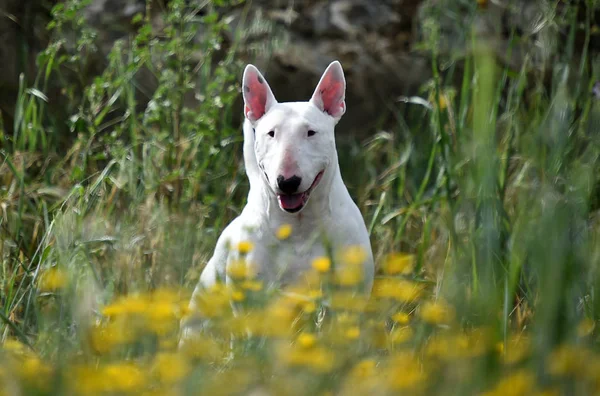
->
[[244, 120, 348, 230]]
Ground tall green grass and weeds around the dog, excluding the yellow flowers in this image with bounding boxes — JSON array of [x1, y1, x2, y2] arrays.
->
[[0, 0, 600, 394]]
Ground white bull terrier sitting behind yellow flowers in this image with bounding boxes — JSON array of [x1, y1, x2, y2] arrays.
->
[[192, 61, 374, 306]]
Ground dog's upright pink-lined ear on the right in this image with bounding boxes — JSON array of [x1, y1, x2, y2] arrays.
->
[[310, 61, 346, 120]]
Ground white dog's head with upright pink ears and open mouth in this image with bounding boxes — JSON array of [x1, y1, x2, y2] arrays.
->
[[242, 61, 346, 213]]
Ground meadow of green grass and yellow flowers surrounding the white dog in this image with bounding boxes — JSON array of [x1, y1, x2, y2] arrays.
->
[[0, 0, 600, 396]]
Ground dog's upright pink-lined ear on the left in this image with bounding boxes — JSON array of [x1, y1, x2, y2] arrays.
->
[[242, 65, 277, 123]]
